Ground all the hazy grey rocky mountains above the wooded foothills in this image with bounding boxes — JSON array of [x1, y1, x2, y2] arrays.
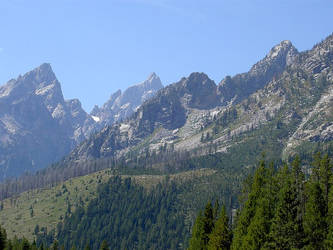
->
[[0, 35, 333, 182]]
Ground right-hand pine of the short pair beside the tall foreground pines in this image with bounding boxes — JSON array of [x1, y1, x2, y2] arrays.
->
[[208, 206, 232, 250]]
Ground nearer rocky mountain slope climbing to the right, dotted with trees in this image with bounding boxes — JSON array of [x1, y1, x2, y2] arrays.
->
[[67, 33, 332, 166]]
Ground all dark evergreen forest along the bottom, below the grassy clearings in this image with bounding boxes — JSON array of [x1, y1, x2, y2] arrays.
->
[[0, 153, 333, 249]]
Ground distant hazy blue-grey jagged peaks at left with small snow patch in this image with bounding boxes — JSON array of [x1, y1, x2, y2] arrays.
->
[[0, 63, 162, 180]]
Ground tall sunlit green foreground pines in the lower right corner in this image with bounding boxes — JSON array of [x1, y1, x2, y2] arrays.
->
[[190, 154, 333, 250]]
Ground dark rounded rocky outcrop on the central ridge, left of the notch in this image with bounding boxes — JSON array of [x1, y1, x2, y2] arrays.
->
[[69, 73, 220, 160]]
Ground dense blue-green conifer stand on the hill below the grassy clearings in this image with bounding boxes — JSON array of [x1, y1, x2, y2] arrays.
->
[[46, 177, 188, 249]]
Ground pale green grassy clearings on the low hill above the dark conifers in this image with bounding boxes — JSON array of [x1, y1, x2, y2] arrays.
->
[[0, 169, 216, 240]]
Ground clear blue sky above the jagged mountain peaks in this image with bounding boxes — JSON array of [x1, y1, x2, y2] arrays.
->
[[0, 0, 333, 111]]
